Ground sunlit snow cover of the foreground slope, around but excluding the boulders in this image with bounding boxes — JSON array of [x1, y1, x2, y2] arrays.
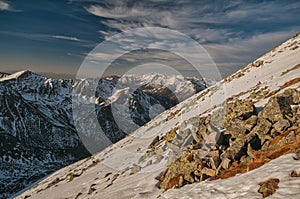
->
[[17, 35, 300, 198]]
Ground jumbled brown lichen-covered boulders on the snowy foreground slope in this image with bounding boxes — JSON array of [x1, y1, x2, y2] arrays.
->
[[158, 89, 300, 190]]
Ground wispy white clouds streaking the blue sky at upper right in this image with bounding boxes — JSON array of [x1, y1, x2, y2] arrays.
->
[[85, 0, 300, 76]]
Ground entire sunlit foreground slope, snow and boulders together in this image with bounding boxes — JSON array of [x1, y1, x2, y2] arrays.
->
[[17, 34, 300, 198]]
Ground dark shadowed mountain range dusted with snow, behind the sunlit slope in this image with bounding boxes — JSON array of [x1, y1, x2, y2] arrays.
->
[[0, 71, 205, 198]]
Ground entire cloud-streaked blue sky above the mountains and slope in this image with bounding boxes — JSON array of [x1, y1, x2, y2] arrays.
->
[[0, 0, 300, 78]]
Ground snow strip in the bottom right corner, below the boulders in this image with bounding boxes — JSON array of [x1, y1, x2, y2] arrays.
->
[[161, 154, 300, 199]]
